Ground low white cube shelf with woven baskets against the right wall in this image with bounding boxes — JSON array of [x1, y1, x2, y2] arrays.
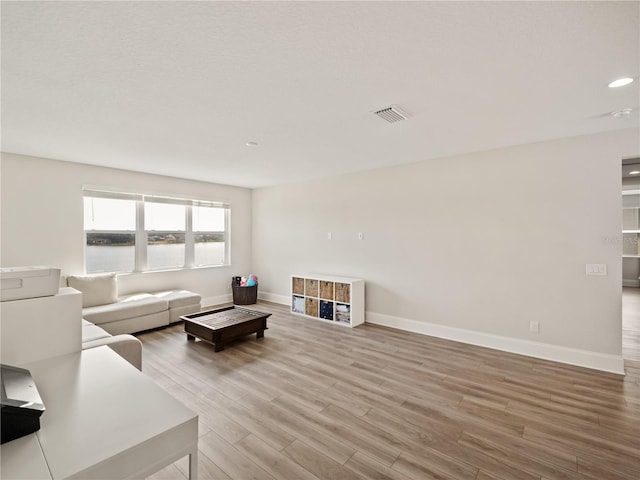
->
[[291, 274, 364, 327]]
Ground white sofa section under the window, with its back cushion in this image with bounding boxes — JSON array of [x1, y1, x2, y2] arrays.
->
[[67, 274, 201, 335]]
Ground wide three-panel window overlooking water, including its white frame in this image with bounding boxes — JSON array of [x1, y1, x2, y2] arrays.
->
[[84, 190, 230, 273]]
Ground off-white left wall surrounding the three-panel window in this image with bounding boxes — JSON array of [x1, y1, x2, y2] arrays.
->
[[0, 153, 251, 304]]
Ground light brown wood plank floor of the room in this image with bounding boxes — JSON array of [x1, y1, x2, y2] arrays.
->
[[139, 302, 640, 480]]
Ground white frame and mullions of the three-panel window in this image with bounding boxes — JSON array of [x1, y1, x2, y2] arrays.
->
[[82, 188, 231, 273]]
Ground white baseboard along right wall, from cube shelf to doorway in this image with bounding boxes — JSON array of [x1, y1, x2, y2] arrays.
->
[[365, 312, 624, 375]]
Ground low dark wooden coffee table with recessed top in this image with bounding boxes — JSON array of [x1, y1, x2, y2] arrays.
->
[[180, 305, 271, 352]]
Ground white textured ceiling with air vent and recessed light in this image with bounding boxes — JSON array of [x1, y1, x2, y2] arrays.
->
[[0, 1, 640, 187]]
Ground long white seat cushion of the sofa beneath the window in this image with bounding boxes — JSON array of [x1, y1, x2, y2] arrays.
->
[[82, 293, 169, 325]]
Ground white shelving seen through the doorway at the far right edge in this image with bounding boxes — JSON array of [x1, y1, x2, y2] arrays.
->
[[622, 190, 640, 287]]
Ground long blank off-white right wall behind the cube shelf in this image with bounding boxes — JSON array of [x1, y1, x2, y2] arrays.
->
[[252, 129, 640, 371]]
